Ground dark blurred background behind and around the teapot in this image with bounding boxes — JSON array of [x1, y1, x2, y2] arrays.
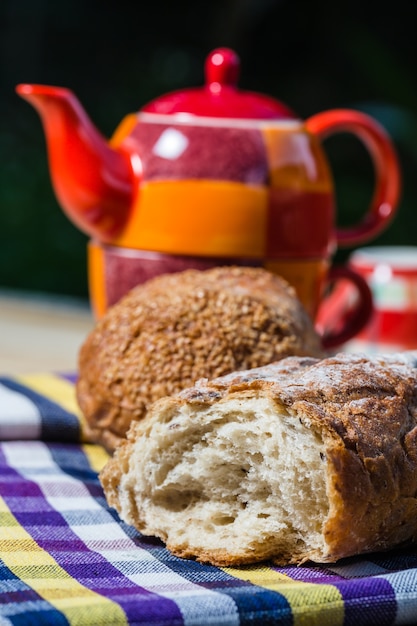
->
[[0, 0, 417, 297]]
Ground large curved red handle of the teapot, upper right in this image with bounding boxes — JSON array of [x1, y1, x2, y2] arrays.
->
[[306, 109, 401, 246]]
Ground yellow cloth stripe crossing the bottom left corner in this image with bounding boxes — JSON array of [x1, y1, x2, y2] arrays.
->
[[0, 497, 127, 626]]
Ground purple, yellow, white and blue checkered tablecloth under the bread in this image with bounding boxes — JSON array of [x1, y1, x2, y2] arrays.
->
[[0, 374, 417, 626]]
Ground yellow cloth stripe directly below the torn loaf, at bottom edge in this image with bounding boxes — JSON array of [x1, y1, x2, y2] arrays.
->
[[221, 565, 344, 626]]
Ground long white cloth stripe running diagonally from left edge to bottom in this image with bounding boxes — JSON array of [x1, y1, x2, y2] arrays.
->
[[3, 441, 240, 626]]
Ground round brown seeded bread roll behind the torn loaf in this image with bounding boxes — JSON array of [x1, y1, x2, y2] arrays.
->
[[77, 267, 321, 452]]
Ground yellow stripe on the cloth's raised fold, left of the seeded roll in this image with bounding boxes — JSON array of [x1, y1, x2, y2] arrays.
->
[[16, 373, 87, 441]]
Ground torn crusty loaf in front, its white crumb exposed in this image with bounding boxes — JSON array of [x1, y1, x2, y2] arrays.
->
[[100, 353, 417, 566]]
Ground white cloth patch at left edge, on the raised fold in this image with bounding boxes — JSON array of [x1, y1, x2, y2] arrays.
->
[[0, 384, 42, 441]]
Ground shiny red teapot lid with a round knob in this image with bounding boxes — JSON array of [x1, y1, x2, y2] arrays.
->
[[142, 48, 297, 120]]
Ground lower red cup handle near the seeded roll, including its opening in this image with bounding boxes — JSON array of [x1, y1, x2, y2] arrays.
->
[[316, 267, 373, 349]]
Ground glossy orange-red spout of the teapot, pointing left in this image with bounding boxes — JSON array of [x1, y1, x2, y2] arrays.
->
[[16, 84, 137, 242]]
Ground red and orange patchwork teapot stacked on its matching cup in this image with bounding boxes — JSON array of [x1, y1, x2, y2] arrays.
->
[[17, 48, 401, 346]]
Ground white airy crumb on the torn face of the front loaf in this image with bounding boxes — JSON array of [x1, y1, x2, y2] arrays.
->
[[119, 395, 329, 558]]
